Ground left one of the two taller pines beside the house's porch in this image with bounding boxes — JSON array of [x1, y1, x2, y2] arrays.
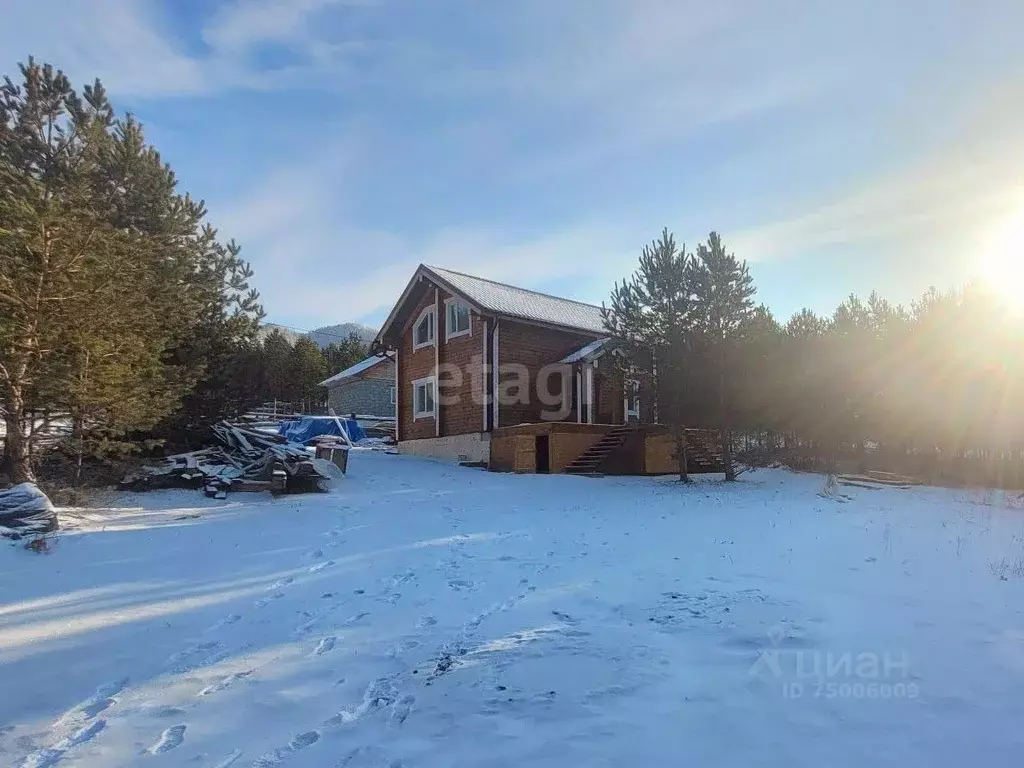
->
[[604, 228, 696, 482]]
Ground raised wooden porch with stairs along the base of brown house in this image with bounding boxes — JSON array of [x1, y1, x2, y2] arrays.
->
[[489, 422, 725, 475]]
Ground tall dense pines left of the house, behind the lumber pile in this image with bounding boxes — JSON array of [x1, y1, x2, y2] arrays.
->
[[0, 59, 366, 482]]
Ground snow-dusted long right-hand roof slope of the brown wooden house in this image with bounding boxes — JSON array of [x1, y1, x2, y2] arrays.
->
[[424, 265, 607, 334]]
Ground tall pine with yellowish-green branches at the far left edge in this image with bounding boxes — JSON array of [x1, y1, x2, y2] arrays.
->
[[0, 60, 132, 482]]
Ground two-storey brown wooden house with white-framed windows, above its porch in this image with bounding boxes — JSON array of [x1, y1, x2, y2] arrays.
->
[[375, 265, 622, 442]]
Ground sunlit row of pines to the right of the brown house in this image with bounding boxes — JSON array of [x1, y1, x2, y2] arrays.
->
[[605, 230, 1024, 487]]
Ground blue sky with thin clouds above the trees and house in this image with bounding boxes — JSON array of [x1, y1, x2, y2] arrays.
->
[[6, 0, 1024, 329]]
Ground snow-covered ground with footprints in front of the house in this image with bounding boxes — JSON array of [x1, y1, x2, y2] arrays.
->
[[0, 452, 1024, 768]]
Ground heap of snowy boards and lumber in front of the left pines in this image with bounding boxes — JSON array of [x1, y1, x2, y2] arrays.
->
[[121, 421, 337, 499]]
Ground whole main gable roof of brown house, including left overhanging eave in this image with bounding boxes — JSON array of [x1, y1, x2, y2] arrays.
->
[[377, 264, 607, 348]]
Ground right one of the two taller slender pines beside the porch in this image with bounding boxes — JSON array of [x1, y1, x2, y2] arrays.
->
[[694, 231, 757, 480]]
